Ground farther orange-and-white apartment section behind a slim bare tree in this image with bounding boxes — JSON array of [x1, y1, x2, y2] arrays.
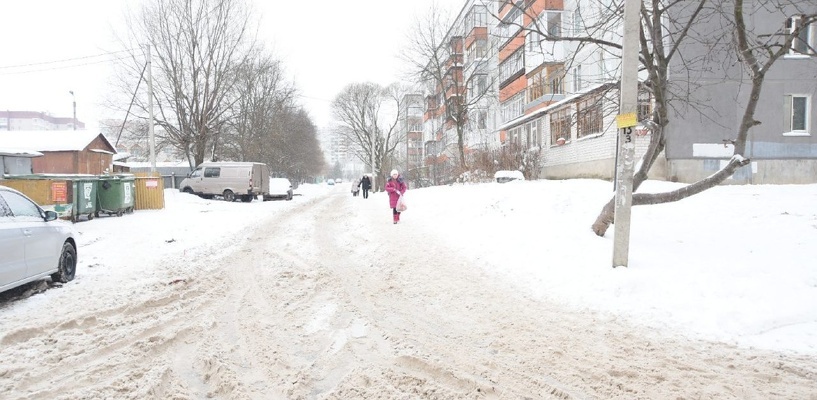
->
[[423, 0, 499, 183]]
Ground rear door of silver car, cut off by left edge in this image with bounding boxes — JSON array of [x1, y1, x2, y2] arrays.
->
[[0, 191, 26, 288]]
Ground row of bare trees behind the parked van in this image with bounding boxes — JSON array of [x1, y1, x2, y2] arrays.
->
[[109, 0, 325, 181]]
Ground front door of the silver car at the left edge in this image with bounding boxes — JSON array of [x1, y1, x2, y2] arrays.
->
[[3, 192, 62, 277]]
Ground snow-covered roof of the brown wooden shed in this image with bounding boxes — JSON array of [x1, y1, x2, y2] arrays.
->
[[0, 131, 115, 152]]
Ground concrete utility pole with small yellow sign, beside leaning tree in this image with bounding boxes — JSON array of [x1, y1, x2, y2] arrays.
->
[[613, 0, 641, 268]]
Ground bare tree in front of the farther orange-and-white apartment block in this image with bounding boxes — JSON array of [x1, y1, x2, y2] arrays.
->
[[402, 3, 497, 171]]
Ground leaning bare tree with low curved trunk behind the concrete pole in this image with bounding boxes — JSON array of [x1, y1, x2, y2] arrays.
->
[[494, 0, 817, 236]]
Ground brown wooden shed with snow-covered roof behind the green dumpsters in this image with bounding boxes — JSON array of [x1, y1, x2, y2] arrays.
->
[[0, 131, 116, 175]]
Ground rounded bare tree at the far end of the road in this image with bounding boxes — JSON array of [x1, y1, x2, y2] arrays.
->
[[332, 83, 406, 191]]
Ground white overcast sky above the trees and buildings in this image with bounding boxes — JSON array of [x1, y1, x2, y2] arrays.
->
[[0, 0, 466, 134]]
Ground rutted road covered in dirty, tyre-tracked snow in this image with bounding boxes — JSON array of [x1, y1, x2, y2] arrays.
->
[[0, 186, 817, 399]]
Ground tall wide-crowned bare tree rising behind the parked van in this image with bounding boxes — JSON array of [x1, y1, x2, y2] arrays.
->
[[116, 0, 255, 165]]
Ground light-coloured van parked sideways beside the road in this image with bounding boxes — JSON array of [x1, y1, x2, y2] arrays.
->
[[179, 162, 269, 202]]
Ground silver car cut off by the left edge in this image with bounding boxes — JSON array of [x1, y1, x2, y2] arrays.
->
[[0, 186, 77, 292]]
